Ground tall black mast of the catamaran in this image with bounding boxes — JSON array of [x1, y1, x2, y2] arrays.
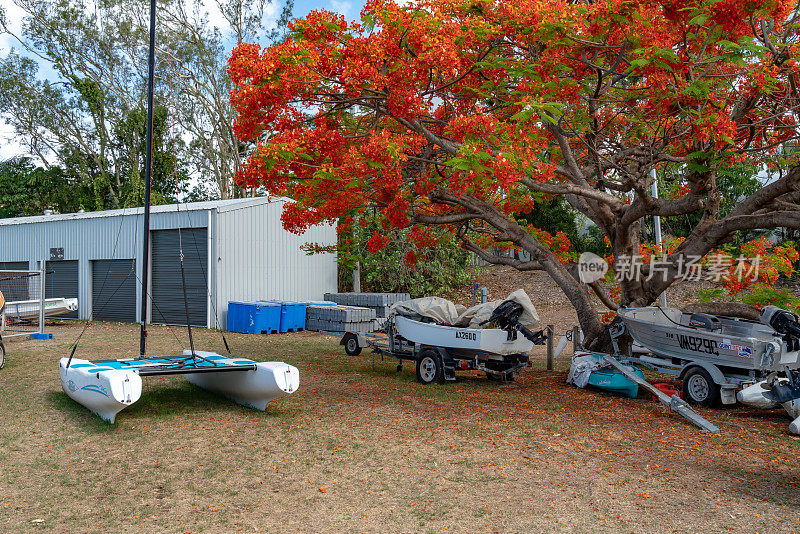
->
[[139, 0, 156, 356]]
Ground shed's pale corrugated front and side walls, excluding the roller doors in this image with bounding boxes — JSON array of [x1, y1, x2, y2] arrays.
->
[[0, 198, 337, 327]]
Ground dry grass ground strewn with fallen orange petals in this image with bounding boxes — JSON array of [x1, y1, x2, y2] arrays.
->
[[0, 320, 800, 533]]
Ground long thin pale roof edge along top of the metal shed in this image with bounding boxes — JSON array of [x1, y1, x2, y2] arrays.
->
[[0, 197, 288, 226]]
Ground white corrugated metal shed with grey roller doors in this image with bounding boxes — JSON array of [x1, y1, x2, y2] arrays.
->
[[0, 197, 337, 328]]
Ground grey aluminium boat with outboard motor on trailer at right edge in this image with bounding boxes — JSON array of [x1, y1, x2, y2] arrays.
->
[[612, 306, 800, 433]]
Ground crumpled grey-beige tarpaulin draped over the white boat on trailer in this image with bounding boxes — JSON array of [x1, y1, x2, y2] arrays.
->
[[389, 289, 539, 328]]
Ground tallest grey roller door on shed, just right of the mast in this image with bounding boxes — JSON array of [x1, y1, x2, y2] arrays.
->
[[150, 228, 208, 326]]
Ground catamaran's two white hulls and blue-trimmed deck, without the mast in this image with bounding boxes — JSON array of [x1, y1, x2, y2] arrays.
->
[[59, 351, 300, 423]]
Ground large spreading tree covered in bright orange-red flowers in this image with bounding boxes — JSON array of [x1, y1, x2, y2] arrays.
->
[[228, 0, 800, 346]]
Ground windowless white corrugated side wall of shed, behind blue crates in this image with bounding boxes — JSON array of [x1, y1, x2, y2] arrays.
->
[[213, 201, 337, 325]]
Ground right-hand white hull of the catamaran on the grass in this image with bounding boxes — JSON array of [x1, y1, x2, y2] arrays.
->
[[184, 351, 300, 411]]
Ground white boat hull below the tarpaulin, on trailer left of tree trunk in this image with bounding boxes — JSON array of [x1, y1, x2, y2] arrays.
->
[[394, 315, 533, 355]]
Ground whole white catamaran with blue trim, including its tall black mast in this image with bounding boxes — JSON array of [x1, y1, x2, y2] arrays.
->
[[59, 0, 299, 423]]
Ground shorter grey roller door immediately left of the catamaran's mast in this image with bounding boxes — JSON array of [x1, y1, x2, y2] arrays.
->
[[92, 260, 136, 323]]
